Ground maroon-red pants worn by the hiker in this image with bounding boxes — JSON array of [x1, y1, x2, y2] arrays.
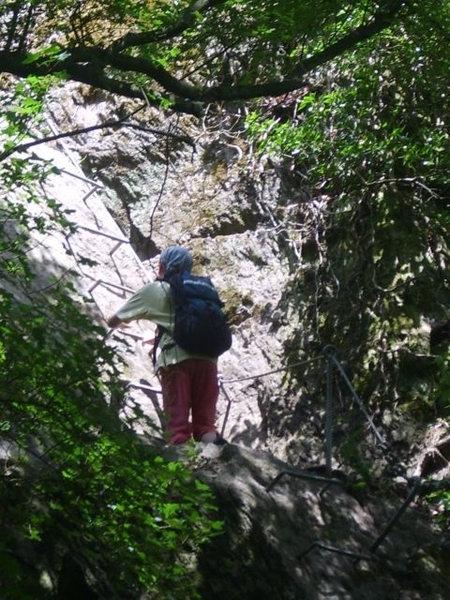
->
[[158, 358, 219, 444]]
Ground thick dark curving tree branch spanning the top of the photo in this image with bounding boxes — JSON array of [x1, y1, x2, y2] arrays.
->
[[0, 0, 414, 117]]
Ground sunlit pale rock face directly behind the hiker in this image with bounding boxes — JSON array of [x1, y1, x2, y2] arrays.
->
[[44, 87, 296, 448]]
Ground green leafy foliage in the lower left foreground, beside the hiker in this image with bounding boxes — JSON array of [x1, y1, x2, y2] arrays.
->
[[0, 159, 220, 600]]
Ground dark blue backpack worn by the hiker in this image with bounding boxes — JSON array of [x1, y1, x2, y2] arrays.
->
[[155, 271, 232, 358]]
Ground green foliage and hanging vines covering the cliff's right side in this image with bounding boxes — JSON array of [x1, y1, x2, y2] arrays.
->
[[247, 2, 450, 462]]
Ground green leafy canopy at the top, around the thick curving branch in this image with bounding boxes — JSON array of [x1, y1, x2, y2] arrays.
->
[[0, 0, 417, 115]]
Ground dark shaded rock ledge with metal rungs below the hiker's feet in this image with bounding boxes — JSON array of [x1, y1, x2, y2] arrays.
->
[[169, 445, 450, 600]]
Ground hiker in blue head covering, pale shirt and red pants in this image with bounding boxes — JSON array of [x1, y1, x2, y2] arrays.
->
[[107, 246, 231, 445]]
